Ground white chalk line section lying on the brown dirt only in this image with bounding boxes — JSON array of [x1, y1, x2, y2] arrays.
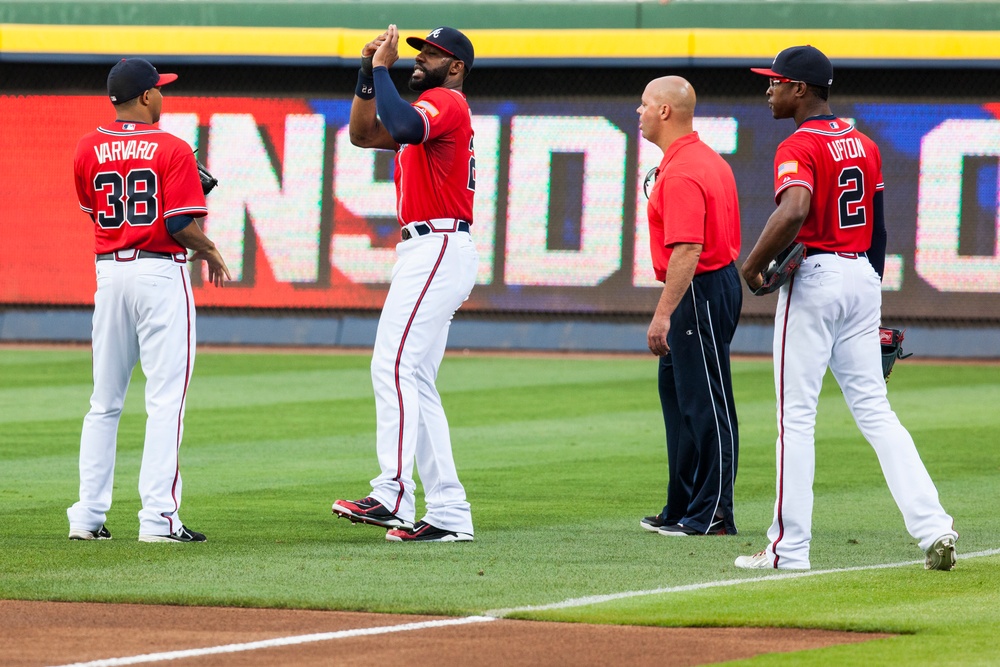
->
[[49, 616, 497, 667]]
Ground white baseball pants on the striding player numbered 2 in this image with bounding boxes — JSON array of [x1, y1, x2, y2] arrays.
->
[[767, 254, 958, 569]]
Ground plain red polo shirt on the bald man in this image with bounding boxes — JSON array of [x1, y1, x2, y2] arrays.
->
[[646, 132, 740, 282]]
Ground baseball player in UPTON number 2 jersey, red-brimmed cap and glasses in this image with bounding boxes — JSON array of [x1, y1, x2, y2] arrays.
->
[[736, 46, 958, 570]]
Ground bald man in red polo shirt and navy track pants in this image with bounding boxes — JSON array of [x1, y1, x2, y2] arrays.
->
[[636, 76, 743, 536]]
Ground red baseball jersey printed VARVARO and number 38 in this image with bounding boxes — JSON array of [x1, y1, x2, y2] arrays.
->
[[73, 121, 208, 254]]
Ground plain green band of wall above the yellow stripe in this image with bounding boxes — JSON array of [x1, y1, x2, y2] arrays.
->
[[0, 0, 1000, 31]]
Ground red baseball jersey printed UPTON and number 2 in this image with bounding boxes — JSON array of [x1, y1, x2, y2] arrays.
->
[[774, 116, 884, 252]]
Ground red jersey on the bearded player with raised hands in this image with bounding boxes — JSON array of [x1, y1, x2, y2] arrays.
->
[[395, 88, 476, 225]]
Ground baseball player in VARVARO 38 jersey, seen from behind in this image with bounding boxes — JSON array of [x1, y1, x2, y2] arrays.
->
[[67, 58, 229, 542]]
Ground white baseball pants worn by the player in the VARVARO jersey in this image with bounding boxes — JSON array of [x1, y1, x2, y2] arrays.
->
[[67, 258, 195, 535]]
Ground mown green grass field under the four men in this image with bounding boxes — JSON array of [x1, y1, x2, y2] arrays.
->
[[0, 348, 1000, 665]]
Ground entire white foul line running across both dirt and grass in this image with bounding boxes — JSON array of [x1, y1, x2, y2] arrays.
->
[[48, 549, 1000, 667]]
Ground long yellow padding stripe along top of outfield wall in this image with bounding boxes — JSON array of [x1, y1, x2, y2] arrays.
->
[[0, 23, 1000, 60]]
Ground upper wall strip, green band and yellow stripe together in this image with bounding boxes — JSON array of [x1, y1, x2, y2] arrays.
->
[[0, 0, 1000, 67]]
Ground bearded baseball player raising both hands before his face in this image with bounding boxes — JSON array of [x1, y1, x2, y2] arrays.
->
[[333, 25, 479, 542]]
